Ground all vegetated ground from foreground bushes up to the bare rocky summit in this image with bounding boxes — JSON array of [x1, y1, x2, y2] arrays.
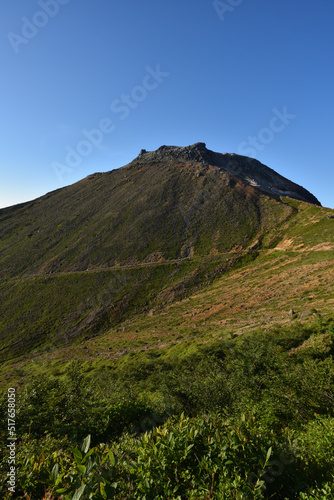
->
[[0, 149, 334, 500]]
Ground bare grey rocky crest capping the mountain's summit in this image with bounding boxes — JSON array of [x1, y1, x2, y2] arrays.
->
[[131, 142, 321, 206]]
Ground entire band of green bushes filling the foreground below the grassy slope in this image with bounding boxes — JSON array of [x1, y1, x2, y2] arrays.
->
[[1, 315, 334, 500]]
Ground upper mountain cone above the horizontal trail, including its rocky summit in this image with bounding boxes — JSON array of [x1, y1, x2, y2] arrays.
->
[[0, 143, 319, 277]]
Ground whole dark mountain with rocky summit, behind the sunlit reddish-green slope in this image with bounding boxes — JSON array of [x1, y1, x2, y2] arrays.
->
[[0, 143, 333, 382]]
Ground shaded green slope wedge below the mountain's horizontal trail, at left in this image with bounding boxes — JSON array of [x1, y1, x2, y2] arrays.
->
[[0, 256, 248, 361]]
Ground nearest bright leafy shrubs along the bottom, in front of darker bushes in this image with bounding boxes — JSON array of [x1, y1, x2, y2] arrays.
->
[[2, 414, 334, 500]]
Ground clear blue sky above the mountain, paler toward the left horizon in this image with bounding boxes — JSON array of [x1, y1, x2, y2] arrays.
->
[[0, 0, 334, 207]]
